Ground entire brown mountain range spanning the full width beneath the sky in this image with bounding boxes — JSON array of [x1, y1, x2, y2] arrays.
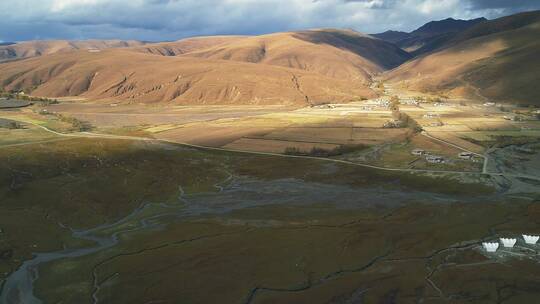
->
[[0, 11, 540, 106]]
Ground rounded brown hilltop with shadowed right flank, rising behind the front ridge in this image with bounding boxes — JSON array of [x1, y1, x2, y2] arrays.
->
[[183, 30, 410, 84]]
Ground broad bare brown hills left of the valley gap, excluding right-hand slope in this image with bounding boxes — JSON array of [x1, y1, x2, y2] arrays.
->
[[0, 29, 410, 106]]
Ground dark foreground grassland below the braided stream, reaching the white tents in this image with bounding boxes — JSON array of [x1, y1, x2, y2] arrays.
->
[[31, 203, 540, 303]]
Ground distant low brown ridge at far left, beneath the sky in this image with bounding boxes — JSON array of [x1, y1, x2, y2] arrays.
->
[[0, 40, 144, 62]]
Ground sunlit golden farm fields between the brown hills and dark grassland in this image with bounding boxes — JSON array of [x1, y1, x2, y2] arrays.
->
[[0, 90, 540, 172]]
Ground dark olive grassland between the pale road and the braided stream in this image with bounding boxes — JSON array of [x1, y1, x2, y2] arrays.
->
[[0, 129, 498, 296]]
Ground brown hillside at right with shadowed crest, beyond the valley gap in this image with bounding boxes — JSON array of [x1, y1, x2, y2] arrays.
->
[[386, 12, 540, 105]]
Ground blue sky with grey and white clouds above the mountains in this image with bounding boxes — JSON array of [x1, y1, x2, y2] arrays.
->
[[0, 0, 540, 42]]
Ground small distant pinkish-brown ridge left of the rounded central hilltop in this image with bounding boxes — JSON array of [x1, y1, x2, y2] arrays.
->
[[133, 36, 246, 56]]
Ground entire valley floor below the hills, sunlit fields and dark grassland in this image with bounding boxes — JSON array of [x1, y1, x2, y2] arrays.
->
[[0, 88, 540, 303]]
